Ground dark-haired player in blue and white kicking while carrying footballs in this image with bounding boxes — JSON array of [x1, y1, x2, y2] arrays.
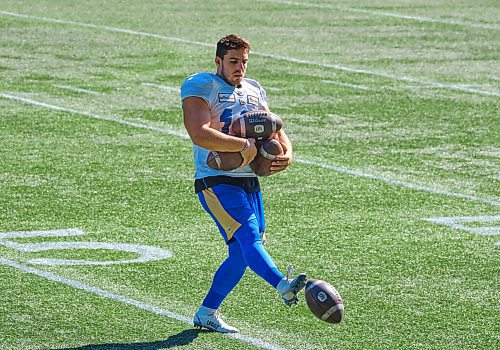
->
[[181, 34, 307, 333]]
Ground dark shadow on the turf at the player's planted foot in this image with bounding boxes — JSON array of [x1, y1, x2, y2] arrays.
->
[[63, 329, 203, 350]]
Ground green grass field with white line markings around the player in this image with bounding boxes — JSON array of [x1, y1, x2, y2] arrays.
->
[[0, 0, 500, 350]]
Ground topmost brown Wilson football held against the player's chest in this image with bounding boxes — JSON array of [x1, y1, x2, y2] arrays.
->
[[229, 110, 283, 141]]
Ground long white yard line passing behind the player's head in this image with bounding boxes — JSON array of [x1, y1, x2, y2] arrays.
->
[[0, 11, 500, 97]]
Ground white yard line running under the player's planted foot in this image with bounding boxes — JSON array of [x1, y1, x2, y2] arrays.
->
[[0, 258, 286, 350]]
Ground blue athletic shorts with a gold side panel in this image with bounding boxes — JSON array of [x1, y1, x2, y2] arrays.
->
[[198, 184, 266, 244]]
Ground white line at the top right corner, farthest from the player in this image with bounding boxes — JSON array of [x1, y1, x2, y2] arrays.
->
[[260, 0, 500, 30]]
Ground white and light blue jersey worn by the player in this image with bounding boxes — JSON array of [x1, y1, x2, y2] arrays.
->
[[181, 73, 267, 179]]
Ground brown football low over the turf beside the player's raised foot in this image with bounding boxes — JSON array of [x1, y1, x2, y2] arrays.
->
[[305, 279, 344, 323]]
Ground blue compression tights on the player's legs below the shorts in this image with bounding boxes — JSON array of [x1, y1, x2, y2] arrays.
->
[[202, 219, 284, 309]]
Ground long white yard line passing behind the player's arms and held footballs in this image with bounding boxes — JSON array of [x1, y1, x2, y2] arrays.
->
[[0, 93, 500, 206]]
